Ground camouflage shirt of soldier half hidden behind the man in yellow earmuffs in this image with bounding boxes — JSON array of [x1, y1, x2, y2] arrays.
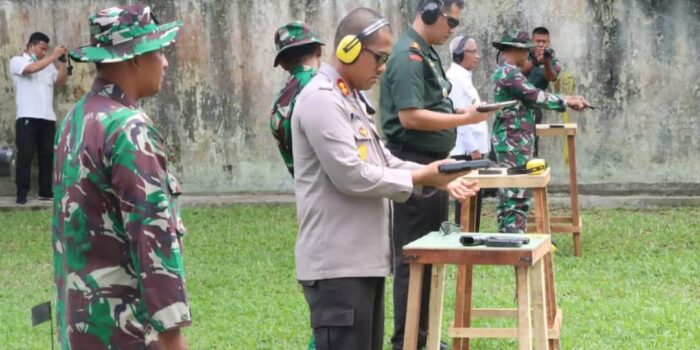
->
[[270, 66, 316, 177]]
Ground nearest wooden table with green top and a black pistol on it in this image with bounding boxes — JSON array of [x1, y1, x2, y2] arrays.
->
[[403, 232, 562, 350]]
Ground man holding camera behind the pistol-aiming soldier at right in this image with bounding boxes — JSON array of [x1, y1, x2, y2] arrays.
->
[[522, 27, 561, 156]]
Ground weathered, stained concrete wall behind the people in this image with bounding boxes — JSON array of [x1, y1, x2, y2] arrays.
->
[[0, 0, 700, 194]]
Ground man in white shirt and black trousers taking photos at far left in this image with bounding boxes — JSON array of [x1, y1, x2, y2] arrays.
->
[[10, 32, 68, 204]]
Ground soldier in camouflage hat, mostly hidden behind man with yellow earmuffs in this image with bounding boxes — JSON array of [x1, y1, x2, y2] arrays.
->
[[270, 21, 323, 176]]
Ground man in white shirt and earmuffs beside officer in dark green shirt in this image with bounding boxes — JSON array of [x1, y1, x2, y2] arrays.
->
[[446, 35, 491, 231]]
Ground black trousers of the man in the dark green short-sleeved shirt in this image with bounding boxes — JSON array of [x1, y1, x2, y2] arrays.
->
[[387, 143, 449, 349]]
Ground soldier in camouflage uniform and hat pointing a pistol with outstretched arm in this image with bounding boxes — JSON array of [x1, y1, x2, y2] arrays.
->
[[491, 32, 589, 233]]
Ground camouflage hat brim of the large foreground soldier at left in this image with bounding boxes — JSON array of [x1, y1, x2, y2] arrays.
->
[[68, 21, 182, 63]]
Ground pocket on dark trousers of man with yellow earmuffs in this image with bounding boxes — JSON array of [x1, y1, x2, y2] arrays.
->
[[311, 309, 357, 349]]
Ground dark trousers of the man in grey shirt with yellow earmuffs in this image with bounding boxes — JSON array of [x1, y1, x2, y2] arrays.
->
[[300, 277, 384, 350]]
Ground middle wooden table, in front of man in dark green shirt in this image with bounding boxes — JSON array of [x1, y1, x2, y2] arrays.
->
[[454, 168, 559, 350]]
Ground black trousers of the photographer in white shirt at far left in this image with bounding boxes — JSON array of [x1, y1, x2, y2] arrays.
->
[[15, 118, 56, 199]]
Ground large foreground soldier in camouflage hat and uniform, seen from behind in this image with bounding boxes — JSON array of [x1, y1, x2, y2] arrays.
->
[[52, 5, 191, 350]]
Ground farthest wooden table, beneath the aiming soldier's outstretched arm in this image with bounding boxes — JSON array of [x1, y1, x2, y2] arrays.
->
[[536, 123, 583, 256]]
